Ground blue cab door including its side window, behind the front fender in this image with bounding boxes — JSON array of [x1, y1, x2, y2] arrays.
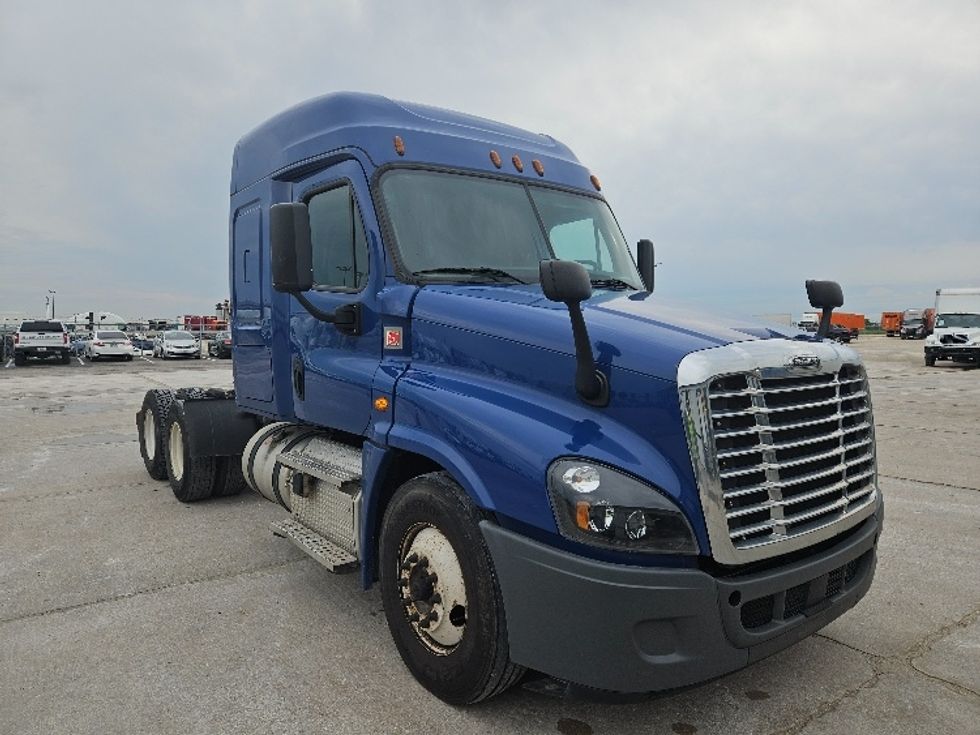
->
[[289, 160, 385, 434]]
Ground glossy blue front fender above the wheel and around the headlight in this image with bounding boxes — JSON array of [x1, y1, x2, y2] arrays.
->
[[388, 366, 701, 536]]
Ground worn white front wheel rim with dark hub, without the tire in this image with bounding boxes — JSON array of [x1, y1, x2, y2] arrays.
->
[[398, 524, 468, 655]]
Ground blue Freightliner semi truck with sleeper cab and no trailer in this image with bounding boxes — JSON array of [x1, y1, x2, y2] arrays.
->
[[137, 93, 882, 704]]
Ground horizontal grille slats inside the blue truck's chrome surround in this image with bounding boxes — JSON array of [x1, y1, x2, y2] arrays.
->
[[708, 365, 874, 548]]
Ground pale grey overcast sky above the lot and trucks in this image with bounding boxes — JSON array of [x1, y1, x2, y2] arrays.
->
[[0, 0, 980, 318]]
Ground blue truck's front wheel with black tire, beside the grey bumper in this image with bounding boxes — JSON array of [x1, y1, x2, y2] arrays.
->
[[379, 473, 524, 704]]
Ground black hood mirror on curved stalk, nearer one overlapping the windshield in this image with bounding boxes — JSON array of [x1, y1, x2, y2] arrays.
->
[[538, 260, 609, 406]]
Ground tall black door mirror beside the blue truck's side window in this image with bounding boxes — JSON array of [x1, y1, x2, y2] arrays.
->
[[269, 202, 313, 294]]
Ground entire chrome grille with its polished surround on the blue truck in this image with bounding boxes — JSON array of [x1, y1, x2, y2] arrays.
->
[[679, 343, 877, 564]]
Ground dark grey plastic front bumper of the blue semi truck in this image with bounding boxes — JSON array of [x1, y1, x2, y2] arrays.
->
[[480, 505, 882, 692]]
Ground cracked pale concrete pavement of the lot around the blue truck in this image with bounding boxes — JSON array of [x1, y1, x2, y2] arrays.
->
[[0, 336, 980, 735]]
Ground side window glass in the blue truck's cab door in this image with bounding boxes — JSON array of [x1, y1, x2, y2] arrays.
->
[[308, 184, 368, 291]]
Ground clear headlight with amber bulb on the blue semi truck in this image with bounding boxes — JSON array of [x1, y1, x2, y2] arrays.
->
[[548, 459, 698, 554]]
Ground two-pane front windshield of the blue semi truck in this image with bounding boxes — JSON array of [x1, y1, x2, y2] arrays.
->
[[381, 169, 640, 289]]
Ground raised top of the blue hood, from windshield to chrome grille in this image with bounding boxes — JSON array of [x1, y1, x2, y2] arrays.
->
[[412, 284, 801, 381]]
